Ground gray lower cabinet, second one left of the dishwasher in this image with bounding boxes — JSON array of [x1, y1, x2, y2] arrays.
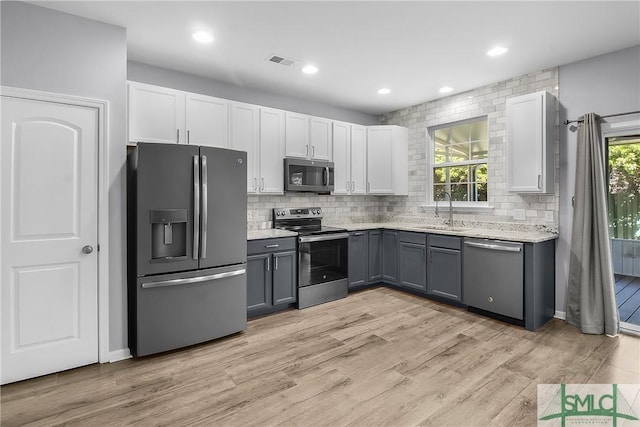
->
[[398, 231, 427, 292]]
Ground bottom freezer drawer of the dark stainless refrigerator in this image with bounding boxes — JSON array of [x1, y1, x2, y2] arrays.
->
[[129, 264, 247, 356]]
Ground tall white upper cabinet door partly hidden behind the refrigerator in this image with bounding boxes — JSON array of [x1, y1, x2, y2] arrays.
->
[[230, 102, 260, 193]]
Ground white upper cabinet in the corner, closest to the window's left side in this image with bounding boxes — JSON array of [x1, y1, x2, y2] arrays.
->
[[367, 126, 409, 196]]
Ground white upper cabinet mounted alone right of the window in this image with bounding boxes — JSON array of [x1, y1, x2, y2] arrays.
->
[[506, 91, 556, 193]]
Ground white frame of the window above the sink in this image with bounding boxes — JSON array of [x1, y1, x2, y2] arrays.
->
[[425, 115, 493, 212]]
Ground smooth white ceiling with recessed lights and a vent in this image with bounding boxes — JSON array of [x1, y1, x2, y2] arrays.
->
[[30, 0, 640, 114]]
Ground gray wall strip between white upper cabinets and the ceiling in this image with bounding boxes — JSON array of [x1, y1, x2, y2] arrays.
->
[[127, 61, 378, 125]]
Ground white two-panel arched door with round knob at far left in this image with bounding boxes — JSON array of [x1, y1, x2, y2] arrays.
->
[[0, 96, 98, 384]]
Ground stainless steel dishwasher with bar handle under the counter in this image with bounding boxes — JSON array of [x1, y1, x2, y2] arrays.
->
[[463, 238, 524, 320]]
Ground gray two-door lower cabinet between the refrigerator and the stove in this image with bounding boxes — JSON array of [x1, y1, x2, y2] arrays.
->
[[247, 237, 297, 315]]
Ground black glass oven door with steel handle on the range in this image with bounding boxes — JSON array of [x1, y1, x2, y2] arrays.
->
[[298, 233, 349, 288]]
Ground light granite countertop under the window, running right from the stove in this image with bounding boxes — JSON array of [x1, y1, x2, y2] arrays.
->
[[327, 222, 558, 243]]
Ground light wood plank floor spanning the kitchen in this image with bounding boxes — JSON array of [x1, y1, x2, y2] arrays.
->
[[1, 288, 640, 426]]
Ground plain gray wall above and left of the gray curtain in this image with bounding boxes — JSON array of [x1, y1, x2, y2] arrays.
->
[[556, 46, 640, 312]]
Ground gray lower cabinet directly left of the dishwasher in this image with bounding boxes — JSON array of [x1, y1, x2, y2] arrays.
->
[[427, 234, 462, 302]]
